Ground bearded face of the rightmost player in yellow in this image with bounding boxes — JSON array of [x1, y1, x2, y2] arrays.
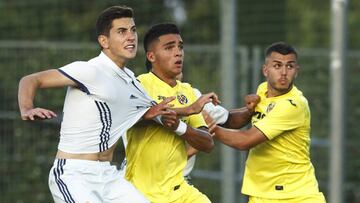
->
[[263, 52, 299, 96]]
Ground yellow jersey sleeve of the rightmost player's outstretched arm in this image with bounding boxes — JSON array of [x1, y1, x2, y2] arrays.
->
[[254, 100, 306, 140]]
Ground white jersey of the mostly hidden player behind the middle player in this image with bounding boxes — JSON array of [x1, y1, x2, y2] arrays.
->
[[184, 88, 229, 176]]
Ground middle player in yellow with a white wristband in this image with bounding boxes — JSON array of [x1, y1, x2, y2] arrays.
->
[[125, 23, 214, 203]]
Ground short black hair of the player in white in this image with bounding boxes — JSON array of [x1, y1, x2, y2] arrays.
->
[[96, 6, 134, 36]]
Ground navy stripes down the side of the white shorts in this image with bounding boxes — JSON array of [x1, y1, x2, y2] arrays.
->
[[53, 159, 75, 203]]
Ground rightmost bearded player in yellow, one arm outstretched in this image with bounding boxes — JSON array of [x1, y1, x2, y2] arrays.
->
[[211, 42, 325, 203]]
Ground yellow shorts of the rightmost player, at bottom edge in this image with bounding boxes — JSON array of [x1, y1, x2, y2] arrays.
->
[[249, 192, 326, 203]]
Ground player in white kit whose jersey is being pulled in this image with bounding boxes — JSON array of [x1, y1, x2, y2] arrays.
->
[[18, 6, 176, 203]]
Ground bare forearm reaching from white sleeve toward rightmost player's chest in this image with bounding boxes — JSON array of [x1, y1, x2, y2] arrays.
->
[[222, 107, 252, 129]]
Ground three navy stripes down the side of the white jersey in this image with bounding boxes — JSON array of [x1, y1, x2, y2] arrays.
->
[[95, 101, 112, 152]]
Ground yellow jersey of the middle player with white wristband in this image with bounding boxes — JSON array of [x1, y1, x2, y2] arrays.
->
[[125, 72, 206, 202]]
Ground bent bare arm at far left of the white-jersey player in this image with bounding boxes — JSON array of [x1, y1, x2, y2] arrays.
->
[[18, 69, 76, 120]]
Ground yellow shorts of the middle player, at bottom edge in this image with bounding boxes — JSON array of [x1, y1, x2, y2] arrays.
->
[[171, 181, 211, 203]]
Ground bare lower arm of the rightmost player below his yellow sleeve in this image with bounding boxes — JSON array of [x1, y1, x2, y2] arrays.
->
[[211, 126, 267, 150]]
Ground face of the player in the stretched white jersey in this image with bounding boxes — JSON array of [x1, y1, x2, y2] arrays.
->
[[103, 18, 138, 65]]
